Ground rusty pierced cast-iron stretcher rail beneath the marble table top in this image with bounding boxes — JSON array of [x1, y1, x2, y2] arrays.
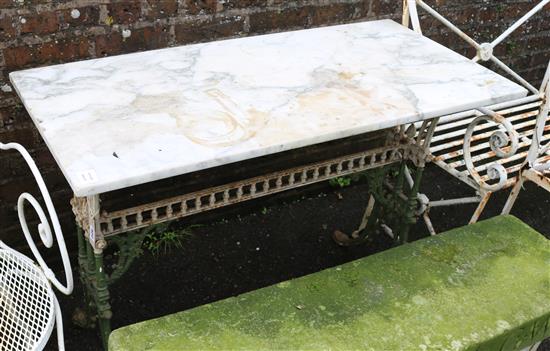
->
[[97, 144, 411, 236]]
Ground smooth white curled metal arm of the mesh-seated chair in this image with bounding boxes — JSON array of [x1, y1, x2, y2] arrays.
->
[[0, 143, 74, 295]]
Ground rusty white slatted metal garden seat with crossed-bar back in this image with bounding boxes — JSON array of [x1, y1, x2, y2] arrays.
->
[[403, 0, 550, 234]]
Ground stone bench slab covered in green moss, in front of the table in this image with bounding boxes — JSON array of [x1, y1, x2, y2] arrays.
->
[[109, 216, 550, 351]]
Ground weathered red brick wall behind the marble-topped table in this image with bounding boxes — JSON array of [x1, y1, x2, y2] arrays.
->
[[0, 0, 550, 248]]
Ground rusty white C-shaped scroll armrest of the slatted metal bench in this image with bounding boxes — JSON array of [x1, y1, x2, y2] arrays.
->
[[463, 108, 518, 192]]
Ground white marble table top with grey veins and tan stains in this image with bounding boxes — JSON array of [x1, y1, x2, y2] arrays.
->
[[10, 20, 527, 196]]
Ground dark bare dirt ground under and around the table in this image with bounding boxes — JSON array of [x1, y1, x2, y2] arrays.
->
[[50, 166, 550, 351]]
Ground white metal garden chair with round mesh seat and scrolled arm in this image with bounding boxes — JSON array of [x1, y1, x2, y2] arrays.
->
[[0, 143, 73, 351]]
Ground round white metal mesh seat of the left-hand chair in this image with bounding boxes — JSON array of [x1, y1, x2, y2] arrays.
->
[[0, 249, 55, 351]]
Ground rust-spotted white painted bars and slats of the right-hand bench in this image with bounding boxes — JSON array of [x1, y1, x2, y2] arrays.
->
[[403, 0, 550, 234]]
